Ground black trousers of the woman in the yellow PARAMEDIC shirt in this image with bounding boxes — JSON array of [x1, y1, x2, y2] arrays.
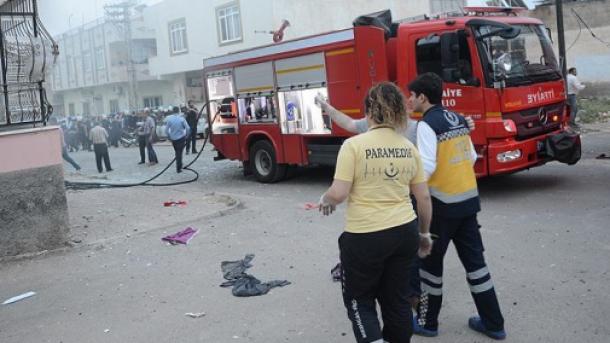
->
[[339, 220, 419, 343]]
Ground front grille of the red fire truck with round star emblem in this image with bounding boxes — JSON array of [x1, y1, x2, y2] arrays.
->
[[502, 101, 565, 140]]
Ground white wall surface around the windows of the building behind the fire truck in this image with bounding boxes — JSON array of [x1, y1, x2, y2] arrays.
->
[[143, 0, 434, 75]]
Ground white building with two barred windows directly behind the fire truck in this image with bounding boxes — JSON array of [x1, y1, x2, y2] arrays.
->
[[143, 0, 464, 103]]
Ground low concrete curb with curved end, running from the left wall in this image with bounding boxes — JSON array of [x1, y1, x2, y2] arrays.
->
[[0, 192, 244, 269]]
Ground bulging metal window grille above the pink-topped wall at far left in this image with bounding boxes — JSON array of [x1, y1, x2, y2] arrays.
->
[[0, 0, 58, 126]]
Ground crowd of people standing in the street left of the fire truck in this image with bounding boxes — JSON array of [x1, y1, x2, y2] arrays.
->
[[51, 101, 199, 173]]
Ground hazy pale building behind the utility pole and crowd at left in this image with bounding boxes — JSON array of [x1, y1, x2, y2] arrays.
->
[[49, 6, 171, 116]]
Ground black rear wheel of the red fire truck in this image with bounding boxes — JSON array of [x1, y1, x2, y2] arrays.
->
[[250, 140, 286, 183]]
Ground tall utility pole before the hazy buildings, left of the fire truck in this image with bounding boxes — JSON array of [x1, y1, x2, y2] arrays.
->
[[104, 0, 139, 111]]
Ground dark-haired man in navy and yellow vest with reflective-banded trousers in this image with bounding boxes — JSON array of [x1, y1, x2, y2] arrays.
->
[[408, 73, 506, 339]]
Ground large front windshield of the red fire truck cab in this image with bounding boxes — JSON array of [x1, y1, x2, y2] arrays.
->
[[477, 24, 561, 87]]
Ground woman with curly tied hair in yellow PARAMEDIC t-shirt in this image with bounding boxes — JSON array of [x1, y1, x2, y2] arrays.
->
[[320, 82, 432, 343]]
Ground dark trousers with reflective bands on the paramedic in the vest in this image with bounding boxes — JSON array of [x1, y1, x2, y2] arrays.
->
[[417, 214, 504, 331]]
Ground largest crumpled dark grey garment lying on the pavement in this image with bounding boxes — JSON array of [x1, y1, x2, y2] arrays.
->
[[220, 254, 290, 297]]
